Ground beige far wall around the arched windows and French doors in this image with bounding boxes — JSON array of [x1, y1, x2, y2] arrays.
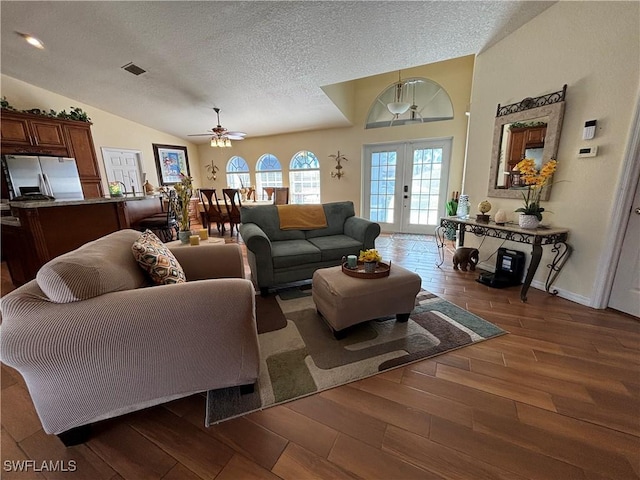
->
[[199, 56, 474, 212]]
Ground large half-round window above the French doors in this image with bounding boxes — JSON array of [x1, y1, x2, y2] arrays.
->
[[365, 77, 453, 128]]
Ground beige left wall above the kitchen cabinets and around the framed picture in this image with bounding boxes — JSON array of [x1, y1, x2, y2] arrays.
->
[[0, 75, 200, 193]]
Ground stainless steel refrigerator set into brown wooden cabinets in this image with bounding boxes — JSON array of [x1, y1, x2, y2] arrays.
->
[[4, 155, 84, 200]]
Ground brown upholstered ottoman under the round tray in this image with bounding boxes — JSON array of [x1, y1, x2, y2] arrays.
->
[[311, 265, 421, 338]]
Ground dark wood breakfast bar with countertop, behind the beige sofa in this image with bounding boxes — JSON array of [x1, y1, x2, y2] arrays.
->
[[0, 196, 162, 286]]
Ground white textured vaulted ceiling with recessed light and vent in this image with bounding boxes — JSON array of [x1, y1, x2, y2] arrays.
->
[[0, 1, 554, 142]]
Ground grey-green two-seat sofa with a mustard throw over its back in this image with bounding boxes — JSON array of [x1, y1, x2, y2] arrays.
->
[[240, 201, 380, 296]]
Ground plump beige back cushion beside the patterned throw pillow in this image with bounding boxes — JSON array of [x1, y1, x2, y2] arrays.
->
[[36, 230, 147, 303]]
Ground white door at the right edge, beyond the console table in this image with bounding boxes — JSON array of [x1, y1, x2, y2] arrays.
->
[[609, 178, 640, 317]]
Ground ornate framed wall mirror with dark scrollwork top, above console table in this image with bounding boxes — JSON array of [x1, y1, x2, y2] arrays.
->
[[487, 85, 567, 200]]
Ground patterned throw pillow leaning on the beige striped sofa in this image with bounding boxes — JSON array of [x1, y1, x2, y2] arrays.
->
[[131, 230, 187, 285]]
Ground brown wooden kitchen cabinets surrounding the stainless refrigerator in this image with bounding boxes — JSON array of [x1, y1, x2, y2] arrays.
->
[[0, 110, 103, 198]]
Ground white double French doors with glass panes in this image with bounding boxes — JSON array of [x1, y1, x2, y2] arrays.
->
[[363, 138, 451, 234]]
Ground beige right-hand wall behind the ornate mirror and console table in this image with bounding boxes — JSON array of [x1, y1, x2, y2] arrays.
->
[[464, 2, 640, 304]]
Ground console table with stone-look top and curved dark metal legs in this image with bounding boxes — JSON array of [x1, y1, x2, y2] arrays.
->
[[436, 217, 573, 302]]
